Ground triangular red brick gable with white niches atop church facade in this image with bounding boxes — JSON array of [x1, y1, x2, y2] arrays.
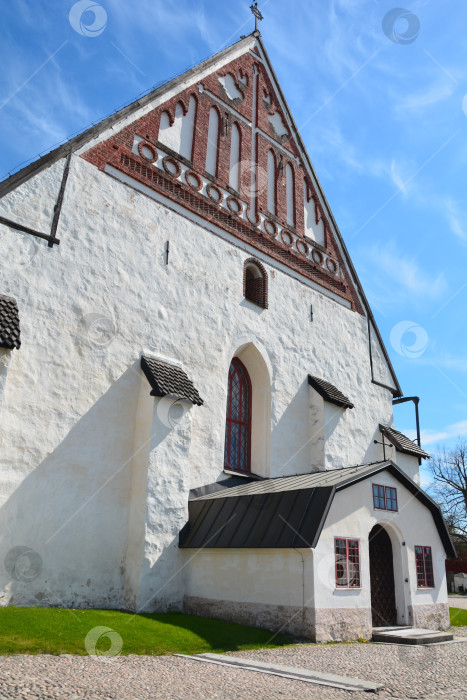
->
[[82, 51, 363, 314]]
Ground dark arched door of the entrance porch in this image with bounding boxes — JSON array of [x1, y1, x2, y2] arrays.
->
[[368, 525, 397, 627]]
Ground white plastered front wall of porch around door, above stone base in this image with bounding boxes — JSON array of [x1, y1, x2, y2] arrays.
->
[[314, 472, 447, 624]]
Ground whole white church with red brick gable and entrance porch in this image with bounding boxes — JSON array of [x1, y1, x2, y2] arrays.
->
[[0, 30, 454, 641]]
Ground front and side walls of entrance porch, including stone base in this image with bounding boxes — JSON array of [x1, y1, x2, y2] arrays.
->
[[184, 472, 448, 641]]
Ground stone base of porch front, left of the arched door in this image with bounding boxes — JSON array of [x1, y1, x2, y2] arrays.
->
[[315, 608, 372, 642]]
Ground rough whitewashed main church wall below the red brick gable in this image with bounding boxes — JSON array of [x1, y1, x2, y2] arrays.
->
[[0, 156, 398, 606]]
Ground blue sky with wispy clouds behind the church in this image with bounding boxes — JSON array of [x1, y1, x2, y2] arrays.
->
[[0, 0, 467, 460]]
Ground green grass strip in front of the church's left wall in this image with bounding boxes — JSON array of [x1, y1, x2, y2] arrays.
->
[[0, 607, 292, 655]]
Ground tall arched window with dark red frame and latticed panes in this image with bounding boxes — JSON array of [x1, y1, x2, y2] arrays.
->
[[224, 357, 251, 472]]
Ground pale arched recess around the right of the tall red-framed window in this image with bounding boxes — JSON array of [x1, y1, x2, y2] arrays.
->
[[229, 342, 271, 477]]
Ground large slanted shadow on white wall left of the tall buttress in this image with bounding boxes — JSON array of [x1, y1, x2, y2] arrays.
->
[[0, 362, 149, 607]]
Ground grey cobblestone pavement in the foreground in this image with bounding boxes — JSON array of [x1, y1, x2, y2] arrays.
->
[[0, 628, 467, 700]]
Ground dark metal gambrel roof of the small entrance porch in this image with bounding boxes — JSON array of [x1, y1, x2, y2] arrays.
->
[[179, 461, 455, 556]]
